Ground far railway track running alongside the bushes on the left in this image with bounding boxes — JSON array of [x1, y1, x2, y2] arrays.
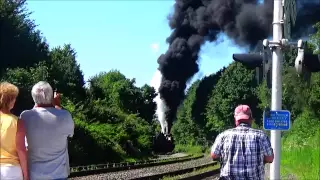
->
[[69, 155, 204, 178]]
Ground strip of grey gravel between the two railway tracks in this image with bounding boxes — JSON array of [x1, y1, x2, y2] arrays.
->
[[69, 157, 212, 180]]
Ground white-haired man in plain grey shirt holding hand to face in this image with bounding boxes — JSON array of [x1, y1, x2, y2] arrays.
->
[[20, 81, 74, 180]]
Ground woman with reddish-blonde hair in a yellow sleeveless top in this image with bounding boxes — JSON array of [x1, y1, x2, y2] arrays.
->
[[0, 82, 29, 180]]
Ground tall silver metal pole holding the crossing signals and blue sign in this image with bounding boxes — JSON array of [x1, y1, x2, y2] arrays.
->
[[270, 0, 283, 180]]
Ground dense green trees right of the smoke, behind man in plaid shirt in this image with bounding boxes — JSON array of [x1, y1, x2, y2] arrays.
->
[[172, 22, 320, 155]]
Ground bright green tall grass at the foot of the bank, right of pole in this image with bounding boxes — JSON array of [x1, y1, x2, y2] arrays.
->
[[281, 130, 320, 180]]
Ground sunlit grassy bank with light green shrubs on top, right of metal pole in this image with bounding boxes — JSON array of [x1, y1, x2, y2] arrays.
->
[[281, 110, 320, 180]]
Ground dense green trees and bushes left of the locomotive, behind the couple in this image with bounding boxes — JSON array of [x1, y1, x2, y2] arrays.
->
[[0, 1, 157, 165]]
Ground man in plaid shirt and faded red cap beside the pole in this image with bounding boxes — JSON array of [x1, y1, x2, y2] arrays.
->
[[211, 105, 274, 180]]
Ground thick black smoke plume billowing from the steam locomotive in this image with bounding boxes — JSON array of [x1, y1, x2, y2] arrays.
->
[[158, 0, 320, 133]]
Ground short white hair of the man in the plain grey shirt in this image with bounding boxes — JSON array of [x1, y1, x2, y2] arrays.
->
[[31, 81, 53, 105]]
